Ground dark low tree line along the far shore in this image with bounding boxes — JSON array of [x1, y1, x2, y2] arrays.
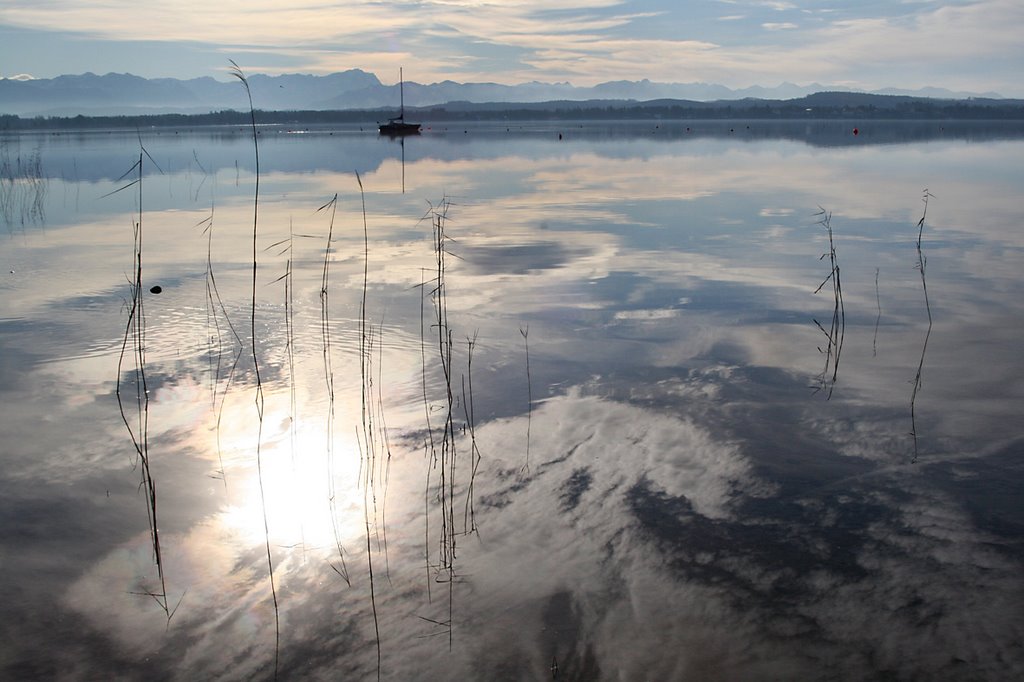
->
[[0, 96, 1024, 130]]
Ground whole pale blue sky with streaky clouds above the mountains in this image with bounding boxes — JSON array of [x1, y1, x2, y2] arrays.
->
[[0, 0, 1024, 97]]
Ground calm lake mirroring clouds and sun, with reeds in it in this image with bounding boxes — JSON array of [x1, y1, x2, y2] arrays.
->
[[0, 121, 1024, 680]]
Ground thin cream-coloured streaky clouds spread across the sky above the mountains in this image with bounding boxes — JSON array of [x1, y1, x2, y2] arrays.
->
[[0, 0, 1024, 94]]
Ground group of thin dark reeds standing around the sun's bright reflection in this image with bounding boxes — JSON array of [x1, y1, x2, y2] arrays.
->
[[103, 61, 532, 678]]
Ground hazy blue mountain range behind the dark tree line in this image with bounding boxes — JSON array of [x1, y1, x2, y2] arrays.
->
[[0, 69, 1000, 117]]
